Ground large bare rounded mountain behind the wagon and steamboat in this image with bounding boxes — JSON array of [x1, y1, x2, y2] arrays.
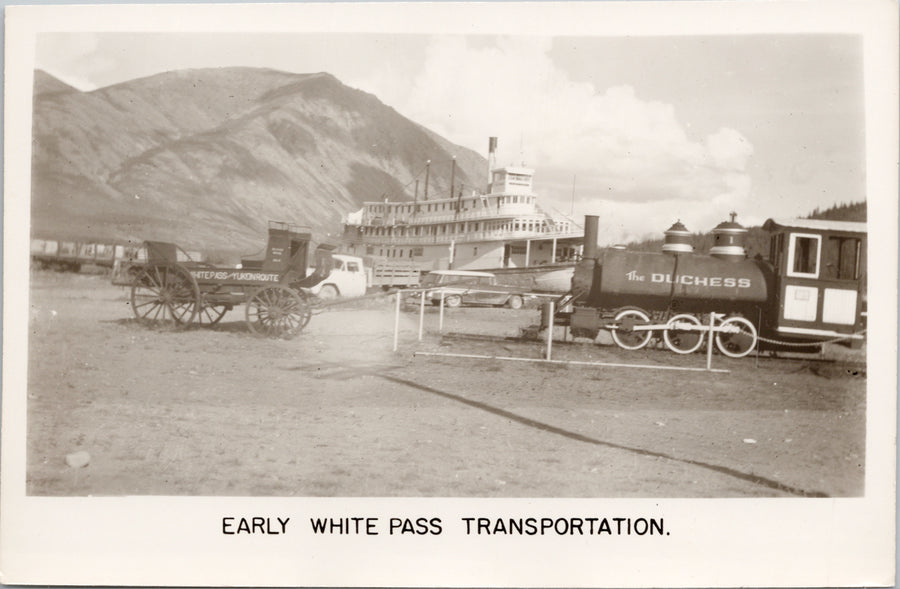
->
[[31, 68, 487, 253]]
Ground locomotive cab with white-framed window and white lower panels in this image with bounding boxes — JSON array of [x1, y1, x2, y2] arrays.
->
[[763, 219, 866, 346]]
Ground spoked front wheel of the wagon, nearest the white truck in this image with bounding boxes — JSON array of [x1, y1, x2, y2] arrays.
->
[[247, 286, 312, 339]]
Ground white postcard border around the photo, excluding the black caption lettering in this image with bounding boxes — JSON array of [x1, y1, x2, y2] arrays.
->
[[0, 1, 898, 586]]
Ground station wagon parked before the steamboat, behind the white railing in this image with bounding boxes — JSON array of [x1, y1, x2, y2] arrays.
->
[[420, 270, 528, 309]]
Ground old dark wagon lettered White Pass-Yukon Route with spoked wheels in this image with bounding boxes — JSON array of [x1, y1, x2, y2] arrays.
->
[[113, 221, 334, 339]]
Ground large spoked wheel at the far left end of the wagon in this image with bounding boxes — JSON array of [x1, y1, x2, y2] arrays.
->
[[131, 264, 200, 329]]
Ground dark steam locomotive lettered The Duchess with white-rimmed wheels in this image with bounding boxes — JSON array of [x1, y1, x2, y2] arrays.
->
[[554, 216, 867, 358]]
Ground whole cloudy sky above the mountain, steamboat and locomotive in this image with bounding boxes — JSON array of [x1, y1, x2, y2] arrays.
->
[[35, 33, 866, 243]]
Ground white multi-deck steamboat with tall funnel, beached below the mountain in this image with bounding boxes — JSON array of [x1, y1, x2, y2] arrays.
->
[[343, 138, 584, 283]]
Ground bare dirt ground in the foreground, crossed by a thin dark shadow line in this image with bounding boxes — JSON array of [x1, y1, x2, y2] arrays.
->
[[27, 271, 866, 497]]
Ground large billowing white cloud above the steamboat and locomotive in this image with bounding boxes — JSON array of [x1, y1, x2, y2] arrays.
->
[[376, 36, 753, 239]]
